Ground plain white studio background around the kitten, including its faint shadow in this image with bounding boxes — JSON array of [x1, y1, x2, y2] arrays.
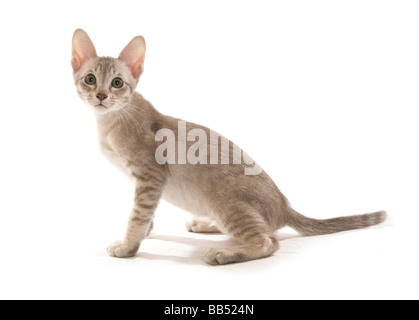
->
[[0, 0, 419, 299]]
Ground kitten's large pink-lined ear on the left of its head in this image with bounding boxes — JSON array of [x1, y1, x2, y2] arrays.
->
[[71, 29, 97, 72]]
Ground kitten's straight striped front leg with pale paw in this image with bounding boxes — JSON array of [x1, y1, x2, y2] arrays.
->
[[108, 178, 163, 258]]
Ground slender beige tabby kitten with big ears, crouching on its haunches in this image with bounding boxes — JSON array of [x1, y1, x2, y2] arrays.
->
[[71, 29, 386, 265]]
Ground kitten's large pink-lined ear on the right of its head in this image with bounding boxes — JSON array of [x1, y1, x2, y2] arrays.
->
[[119, 36, 145, 79]]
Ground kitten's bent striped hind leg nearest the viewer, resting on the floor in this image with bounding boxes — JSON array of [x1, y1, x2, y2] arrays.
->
[[204, 211, 280, 265]]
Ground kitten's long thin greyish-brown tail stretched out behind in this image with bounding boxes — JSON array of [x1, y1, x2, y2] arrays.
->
[[287, 209, 387, 236]]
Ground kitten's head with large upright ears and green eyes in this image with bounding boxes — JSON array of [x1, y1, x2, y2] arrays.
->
[[71, 29, 145, 114]]
